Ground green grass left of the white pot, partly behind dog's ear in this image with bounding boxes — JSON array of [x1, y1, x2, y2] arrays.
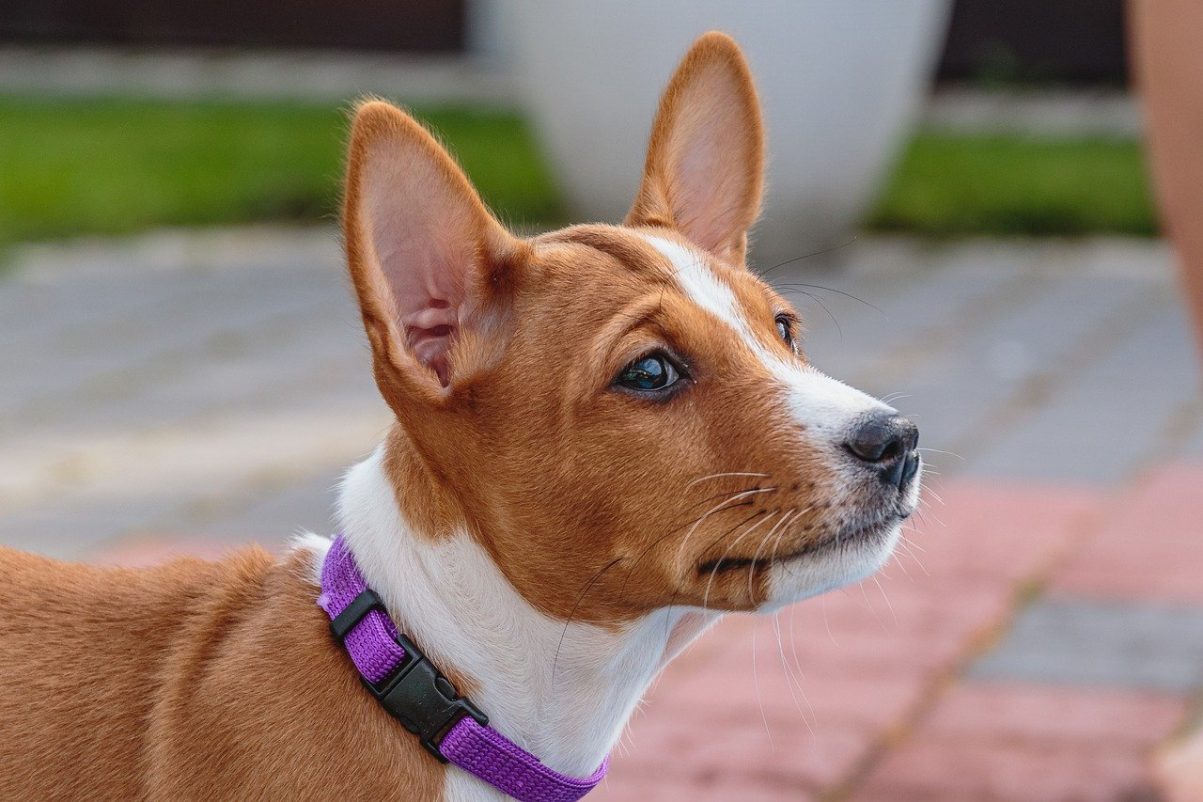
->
[[0, 95, 559, 245]]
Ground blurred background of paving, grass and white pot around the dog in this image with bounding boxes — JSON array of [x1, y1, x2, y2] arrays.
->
[[0, 0, 1203, 802]]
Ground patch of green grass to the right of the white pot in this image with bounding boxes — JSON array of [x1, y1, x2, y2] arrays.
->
[[869, 131, 1157, 237]]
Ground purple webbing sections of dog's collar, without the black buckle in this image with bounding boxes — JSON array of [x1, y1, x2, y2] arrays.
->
[[318, 536, 610, 802]]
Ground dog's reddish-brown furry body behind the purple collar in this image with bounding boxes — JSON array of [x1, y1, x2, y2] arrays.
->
[[0, 548, 440, 800]]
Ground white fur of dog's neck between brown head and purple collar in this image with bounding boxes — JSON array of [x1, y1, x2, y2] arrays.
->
[[319, 446, 717, 800]]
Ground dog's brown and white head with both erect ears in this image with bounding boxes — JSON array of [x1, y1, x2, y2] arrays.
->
[[344, 34, 919, 622]]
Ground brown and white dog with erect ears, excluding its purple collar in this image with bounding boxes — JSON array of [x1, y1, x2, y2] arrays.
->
[[0, 34, 919, 802]]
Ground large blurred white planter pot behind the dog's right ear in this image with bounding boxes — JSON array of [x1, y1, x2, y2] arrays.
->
[[482, 0, 949, 265]]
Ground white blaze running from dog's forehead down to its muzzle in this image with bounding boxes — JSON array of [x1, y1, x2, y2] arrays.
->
[[642, 234, 893, 438]]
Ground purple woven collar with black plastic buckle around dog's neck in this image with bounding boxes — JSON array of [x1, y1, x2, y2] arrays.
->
[[318, 536, 609, 802]]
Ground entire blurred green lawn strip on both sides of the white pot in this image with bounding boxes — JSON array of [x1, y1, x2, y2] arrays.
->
[[0, 94, 1157, 248]]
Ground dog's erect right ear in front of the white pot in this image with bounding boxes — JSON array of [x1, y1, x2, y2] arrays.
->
[[626, 31, 764, 265]]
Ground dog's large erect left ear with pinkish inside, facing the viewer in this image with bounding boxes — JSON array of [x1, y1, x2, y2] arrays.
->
[[343, 101, 522, 416]]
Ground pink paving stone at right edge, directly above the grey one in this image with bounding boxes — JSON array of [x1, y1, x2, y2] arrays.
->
[[1053, 463, 1203, 605]]
